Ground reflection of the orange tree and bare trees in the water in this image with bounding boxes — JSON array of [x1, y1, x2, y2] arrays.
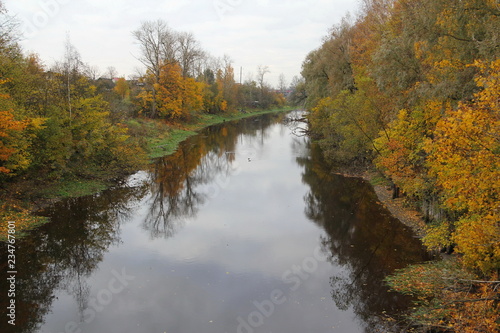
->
[[144, 115, 283, 238]]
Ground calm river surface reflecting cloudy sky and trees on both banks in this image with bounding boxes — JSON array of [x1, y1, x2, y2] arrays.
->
[[0, 111, 426, 333]]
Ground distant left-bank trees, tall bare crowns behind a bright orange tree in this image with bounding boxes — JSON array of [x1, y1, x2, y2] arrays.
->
[[133, 20, 285, 120]]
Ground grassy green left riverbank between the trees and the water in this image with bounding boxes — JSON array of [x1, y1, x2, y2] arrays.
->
[[0, 107, 293, 241]]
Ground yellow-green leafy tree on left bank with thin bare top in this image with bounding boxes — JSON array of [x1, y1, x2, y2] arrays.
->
[[17, 43, 143, 179]]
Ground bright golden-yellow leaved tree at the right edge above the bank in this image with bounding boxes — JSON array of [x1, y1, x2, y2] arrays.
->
[[425, 59, 500, 274]]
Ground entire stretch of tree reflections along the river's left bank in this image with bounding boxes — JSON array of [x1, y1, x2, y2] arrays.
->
[[0, 115, 282, 332]]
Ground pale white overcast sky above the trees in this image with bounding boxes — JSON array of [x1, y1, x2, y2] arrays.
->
[[3, 0, 359, 85]]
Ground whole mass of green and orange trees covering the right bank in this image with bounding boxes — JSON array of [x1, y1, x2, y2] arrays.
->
[[301, 0, 500, 332]]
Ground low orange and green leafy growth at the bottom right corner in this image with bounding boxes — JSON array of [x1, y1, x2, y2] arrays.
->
[[387, 260, 500, 333]]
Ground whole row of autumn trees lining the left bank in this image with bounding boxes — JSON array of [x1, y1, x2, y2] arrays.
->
[[0, 7, 286, 187]]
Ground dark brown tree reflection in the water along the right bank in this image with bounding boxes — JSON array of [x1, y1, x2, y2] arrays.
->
[[297, 141, 430, 332]]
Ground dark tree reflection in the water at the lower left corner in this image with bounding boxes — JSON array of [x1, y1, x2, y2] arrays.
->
[[0, 182, 146, 332]]
